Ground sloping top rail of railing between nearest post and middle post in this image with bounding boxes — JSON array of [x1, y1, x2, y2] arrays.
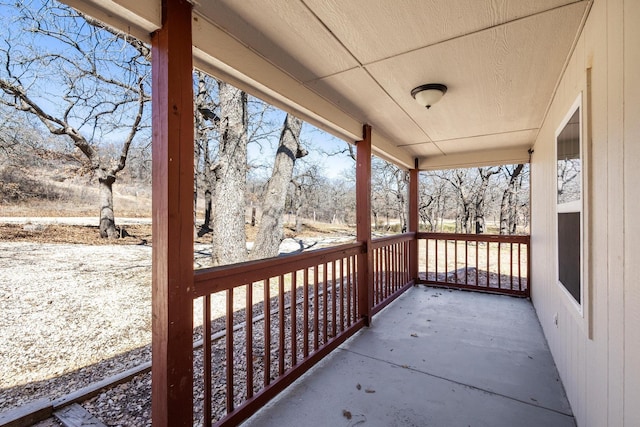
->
[[194, 242, 365, 299]]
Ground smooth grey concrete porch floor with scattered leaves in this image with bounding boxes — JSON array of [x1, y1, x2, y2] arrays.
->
[[243, 286, 575, 427]]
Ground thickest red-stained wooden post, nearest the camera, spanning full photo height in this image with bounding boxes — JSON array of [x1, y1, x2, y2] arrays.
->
[[151, 0, 194, 427]]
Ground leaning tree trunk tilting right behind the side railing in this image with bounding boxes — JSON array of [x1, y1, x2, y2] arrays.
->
[[251, 114, 307, 259]]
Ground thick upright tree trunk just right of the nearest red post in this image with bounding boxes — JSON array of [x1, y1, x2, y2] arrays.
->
[[211, 82, 247, 265]]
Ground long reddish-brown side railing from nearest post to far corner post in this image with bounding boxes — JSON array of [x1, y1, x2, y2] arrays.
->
[[194, 234, 415, 426]]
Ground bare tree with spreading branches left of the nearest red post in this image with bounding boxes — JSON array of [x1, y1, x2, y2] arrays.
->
[[0, 1, 150, 238]]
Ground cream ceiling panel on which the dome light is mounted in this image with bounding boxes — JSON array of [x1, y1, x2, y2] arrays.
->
[[366, 3, 584, 142]]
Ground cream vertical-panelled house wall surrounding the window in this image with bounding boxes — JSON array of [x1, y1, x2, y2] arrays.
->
[[531, 0, 640, 427]]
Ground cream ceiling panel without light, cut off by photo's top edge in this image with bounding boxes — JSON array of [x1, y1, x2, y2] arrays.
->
[[305, 0, 572, 63]]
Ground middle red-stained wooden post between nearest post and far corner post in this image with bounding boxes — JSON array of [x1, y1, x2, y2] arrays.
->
[[356, 125, 373, 326]]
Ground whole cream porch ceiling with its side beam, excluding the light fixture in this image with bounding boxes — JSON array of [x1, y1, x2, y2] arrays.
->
[[66, 0, 591, 168]]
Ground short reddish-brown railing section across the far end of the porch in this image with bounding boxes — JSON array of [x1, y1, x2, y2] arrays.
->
[[418, 233, 531, 297]]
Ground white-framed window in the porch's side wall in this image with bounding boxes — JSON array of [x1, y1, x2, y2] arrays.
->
[[556, 97, 583, 307]]
